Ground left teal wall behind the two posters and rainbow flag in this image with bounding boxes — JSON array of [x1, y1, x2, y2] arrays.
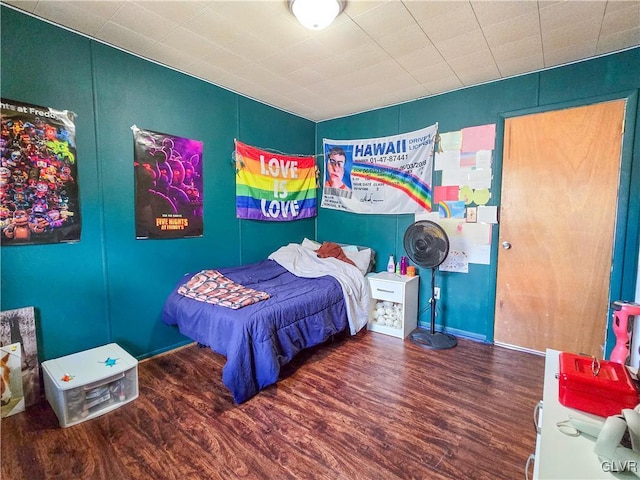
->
[[0, 7, 315, 360]]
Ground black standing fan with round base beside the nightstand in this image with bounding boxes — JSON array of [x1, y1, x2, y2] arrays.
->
[[404, 220, 458, 350]]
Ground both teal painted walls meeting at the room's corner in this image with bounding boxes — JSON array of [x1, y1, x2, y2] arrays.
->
[[0, 7, 640, 360]]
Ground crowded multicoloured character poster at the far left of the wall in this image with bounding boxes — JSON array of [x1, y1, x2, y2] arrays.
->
[[0, 98, 81, 246]]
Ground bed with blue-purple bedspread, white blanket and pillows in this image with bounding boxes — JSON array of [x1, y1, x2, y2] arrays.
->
[[162, 239, 373, 403]]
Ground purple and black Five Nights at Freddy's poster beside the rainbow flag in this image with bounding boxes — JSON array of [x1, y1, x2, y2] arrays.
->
[[131, 125, 203, 239]]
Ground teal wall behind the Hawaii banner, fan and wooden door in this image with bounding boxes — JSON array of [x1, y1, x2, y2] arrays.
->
[[316, 49, 640, 350]]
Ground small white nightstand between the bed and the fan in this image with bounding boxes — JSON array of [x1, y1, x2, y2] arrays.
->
[[367, 272, 420, 338]]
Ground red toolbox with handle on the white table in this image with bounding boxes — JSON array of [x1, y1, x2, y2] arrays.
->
[[558, 352, 640, 417]]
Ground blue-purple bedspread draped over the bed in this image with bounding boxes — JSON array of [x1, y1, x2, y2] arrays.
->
[[162, 260, 349, 403]]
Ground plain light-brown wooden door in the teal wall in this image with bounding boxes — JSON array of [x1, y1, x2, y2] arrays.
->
[[494, 100, 625, 358]]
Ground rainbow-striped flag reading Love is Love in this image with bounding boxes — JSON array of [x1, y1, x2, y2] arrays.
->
[[235, 140, 317, 222]]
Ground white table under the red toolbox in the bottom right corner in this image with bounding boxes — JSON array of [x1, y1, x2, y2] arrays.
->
[[533, 349, 624, 480]]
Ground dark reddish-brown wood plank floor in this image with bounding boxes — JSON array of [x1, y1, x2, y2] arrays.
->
[[1, 332, 544, 480]]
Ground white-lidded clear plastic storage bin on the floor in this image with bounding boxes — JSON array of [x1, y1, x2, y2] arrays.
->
[[42, 343, 138, 427]]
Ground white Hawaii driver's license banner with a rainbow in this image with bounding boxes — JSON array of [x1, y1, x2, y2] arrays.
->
[[321, 123, 438, 214]]
